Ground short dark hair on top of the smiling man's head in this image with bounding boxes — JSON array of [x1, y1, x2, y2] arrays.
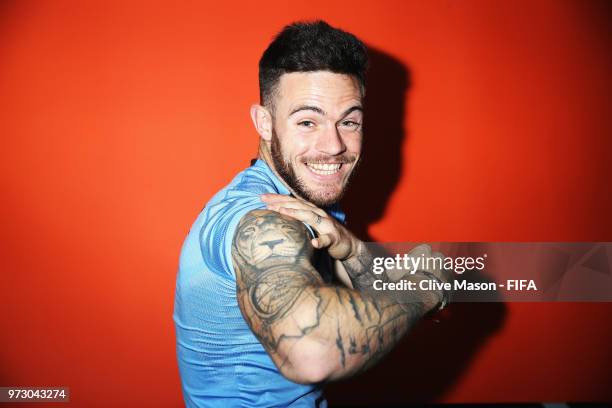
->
[[259, 20, 368, 107]]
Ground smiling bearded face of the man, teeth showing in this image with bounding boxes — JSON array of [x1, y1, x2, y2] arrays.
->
[[271, 71, 363, 207]]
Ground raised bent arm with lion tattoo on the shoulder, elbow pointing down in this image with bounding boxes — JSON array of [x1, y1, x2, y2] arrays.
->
[[232, 210, 437, 383]]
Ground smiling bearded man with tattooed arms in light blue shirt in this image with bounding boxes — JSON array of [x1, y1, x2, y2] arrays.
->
[[174, 21, 444, 407]]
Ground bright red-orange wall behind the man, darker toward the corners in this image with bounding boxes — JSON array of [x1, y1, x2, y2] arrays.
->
[[0, 0, 612, 406]]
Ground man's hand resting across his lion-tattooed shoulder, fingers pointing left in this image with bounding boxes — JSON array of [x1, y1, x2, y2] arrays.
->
[[260, 194, 361, 261]]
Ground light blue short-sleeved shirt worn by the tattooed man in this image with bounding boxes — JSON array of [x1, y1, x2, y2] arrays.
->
[[174, 160, 344, 408]]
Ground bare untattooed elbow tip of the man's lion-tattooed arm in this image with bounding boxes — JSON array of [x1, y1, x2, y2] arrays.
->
[[280, 339, 338, 384]]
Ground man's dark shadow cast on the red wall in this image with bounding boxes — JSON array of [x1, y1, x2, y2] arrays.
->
[[326, 47, 506, 406]]
